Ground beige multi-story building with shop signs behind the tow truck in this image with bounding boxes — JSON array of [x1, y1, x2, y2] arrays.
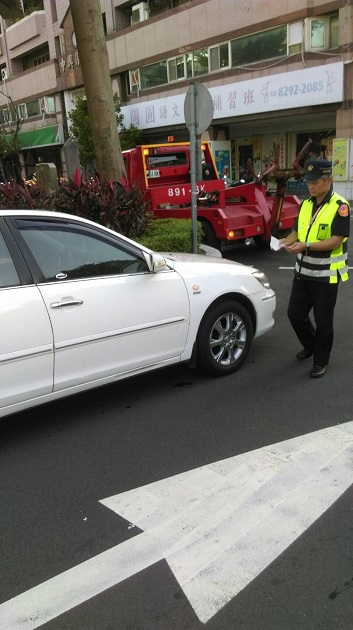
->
[[0, 0, 353, 200]]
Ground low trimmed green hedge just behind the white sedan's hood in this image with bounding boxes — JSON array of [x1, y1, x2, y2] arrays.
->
[[138, 219, 202, 252]]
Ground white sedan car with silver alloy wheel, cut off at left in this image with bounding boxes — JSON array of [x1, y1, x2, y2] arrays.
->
[[0, 210, 276, 417]]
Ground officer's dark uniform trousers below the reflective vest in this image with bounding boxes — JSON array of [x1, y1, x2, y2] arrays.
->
[[288, 277, 338, 365]]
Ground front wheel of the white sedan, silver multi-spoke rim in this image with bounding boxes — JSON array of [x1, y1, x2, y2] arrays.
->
[[196, 299, 254, 376]]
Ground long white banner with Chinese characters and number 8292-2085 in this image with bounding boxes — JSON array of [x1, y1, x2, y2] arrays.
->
[[121, 61, 344, 129]]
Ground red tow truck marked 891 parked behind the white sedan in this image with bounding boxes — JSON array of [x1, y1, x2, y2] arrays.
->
[[123, 142, 304, 250]]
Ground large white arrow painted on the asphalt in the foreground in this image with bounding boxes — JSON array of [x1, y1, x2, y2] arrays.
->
[[0, 422, 353, 630]]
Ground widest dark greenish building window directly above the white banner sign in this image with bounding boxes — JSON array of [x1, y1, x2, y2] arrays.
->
[[230, 25, 287, 66]]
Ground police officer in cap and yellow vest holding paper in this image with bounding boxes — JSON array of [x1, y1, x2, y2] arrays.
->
[[280, 159, 350, 378]]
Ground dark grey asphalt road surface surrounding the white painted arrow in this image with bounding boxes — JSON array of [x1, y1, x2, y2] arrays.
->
[[0, 246, 353, 630]]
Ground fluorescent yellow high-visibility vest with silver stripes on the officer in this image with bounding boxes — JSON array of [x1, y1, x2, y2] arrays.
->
[[294, 193, 349, 284]]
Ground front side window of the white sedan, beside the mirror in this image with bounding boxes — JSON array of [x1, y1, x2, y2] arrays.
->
[[16, 219, 148, 280]]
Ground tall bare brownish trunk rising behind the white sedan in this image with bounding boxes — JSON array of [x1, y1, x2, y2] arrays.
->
[[70, 0, 125, 182]]
